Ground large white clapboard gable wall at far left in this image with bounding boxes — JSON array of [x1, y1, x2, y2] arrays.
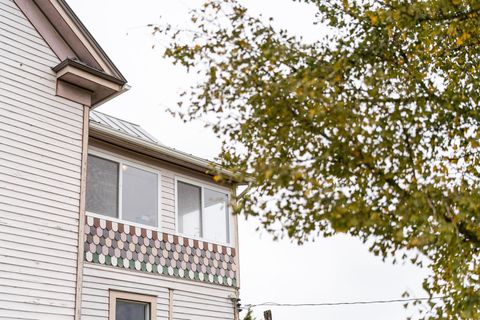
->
[[0, 0, 83, 320]]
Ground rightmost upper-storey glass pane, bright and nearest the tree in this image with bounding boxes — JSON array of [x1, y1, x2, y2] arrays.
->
[[202, 188, 230, 243]]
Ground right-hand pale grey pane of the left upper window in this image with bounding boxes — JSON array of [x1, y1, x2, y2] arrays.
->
[[122, 165, 158, 227]]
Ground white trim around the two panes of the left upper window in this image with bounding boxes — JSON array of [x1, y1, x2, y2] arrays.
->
[[85, 149, 162, 231]]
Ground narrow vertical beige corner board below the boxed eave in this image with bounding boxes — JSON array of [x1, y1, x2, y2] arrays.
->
[[75, 106, 90, 320]]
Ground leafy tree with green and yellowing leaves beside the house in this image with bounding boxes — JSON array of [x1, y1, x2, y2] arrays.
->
[[154, 0, 480, 319]]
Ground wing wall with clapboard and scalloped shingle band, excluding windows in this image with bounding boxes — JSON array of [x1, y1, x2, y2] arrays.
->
[[82, 142, 238, 320]]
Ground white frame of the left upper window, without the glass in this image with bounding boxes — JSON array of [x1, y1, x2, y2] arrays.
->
[[87, 151, 162, 230]]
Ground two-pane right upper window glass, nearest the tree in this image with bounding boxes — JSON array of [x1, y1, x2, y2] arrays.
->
[[177, 181, 230, 243]]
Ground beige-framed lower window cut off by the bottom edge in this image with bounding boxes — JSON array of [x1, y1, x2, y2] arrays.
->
[[109, 291, 157, 320]]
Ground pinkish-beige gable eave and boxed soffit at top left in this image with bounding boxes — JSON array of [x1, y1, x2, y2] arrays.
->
[[14, 0, 128, 107]]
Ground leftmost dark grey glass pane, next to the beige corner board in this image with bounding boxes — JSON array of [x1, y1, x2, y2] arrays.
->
[[86, 155, 118, 217]]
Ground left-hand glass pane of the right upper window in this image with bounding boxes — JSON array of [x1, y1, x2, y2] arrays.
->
[[177, 182, 201, 237]]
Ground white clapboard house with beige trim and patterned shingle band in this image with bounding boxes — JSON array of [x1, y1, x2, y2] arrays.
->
[[0, 0, 239, 320]]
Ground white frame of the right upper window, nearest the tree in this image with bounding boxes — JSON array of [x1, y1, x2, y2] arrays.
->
[[175, 175, 234, 247]]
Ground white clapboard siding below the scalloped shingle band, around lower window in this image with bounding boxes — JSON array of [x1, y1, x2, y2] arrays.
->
[[82, 264, 234, 320]]
